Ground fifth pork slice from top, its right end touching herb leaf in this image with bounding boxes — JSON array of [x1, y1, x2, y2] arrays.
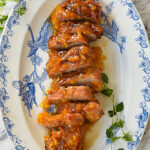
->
[[57, 68, 103, 92]]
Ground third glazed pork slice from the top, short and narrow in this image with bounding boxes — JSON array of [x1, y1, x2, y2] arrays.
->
[[48, 34, 89, 50]]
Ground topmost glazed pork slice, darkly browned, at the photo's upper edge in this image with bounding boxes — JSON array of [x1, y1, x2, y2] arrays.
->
[[52, 1, 101, 24]]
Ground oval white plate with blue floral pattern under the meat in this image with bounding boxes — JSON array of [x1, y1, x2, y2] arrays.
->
[[0, 0, 150, 150]]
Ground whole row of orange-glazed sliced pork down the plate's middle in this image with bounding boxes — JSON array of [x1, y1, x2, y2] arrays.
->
[[37, 0, 105, 150]]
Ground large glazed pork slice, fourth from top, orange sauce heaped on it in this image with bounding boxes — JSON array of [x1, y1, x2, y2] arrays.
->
[[46, 45, 95, 78]]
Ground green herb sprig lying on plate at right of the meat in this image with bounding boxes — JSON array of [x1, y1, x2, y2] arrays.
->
[[101, 73, 133, 150]]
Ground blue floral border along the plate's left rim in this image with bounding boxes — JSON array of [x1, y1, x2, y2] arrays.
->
[[0, 0, 29, 150]]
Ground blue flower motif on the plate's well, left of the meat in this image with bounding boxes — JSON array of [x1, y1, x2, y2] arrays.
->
[[12, 20, 52, 116]]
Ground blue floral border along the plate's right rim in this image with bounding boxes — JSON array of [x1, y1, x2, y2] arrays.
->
[[119, 0, 150, 150]]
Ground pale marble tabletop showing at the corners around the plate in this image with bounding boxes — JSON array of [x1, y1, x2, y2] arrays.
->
[[0, 0, 150, 150]]
